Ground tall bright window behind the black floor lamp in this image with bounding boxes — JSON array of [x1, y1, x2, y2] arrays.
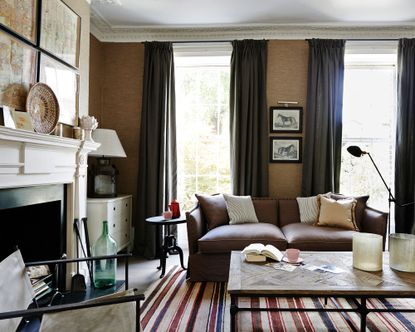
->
[[340, 42, 397, 229]]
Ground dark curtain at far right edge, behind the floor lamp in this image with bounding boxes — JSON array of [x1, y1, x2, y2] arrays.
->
[[392, 39, 415, 234]]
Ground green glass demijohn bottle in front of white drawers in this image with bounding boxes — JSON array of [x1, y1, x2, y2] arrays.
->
[[92, 221, 117, 288]]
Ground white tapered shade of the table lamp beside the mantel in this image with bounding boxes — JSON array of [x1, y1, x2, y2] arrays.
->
[[89, 128, 127, 158]]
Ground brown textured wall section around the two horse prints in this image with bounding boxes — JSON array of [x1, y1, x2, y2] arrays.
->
[[266, 40, 308, 198]]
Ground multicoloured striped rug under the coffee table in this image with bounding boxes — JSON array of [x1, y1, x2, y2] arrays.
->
[[141, 267, 415, 332]]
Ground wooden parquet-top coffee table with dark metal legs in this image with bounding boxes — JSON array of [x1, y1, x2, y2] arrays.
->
[[228, 251, 415, 331]]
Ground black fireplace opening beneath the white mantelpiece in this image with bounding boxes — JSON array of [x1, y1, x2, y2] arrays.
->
[[0, 184, 66, 285]]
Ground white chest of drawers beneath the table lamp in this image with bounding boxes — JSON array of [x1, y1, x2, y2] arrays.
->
[[87, 195, 132, 251]]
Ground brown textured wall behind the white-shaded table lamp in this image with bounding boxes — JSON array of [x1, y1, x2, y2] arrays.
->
[[89, 36, 144, 223]]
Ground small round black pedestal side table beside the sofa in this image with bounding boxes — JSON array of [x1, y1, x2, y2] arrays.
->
[[146, 216, 186, 278]]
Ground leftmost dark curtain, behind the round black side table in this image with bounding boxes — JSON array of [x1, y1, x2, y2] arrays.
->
[[135, 42, 177, 258]]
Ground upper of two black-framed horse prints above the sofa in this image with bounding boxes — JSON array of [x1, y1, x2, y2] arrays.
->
[[269, 106, 303, 133]]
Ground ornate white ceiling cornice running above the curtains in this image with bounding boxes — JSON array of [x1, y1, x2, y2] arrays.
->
[[91, 8, 415, 42]]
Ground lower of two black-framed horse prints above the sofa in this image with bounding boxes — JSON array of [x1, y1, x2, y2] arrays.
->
[[270, 137, 302, 163]]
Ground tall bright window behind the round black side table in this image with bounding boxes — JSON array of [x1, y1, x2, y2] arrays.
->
[[174, 43, 232, 211]]
